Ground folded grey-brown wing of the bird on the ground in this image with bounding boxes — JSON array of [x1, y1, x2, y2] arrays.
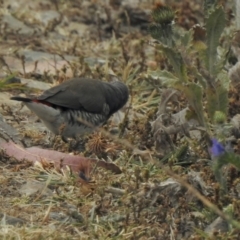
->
[[37, 79, 106, 113]]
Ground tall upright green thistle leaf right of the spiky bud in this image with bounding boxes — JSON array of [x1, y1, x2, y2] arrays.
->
[[205, 7, 226, 76]]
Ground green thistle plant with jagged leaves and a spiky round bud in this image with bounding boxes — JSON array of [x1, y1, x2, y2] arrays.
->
[[149, 1, 229, 132]]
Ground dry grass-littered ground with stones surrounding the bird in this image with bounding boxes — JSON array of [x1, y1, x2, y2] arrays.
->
[[0, 0, 239, 240]]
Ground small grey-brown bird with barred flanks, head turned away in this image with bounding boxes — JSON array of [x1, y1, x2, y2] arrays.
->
[[10, 77, 129, 142]]
